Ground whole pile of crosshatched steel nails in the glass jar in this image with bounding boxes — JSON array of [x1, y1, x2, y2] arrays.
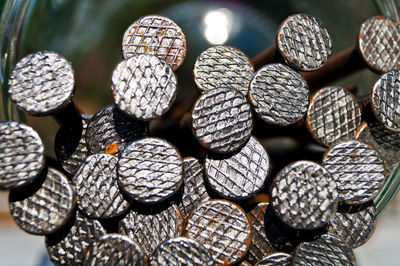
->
[[0, 14, 400, 265]]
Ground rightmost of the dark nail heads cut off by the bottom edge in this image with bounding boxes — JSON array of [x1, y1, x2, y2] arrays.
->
[[292, 235, 356, 266]]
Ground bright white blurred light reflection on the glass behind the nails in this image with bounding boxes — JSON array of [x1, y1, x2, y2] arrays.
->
[[203, 8, 232, 44]]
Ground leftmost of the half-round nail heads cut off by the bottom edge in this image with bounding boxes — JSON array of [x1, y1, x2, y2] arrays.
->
[[83, 234, 146, 266]]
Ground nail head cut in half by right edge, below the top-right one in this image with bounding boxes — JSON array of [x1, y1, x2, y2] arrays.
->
[[371, 69, 400, 132]]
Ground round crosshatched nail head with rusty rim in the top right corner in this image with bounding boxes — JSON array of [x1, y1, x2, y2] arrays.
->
[[358, 16, 400, 73]]
